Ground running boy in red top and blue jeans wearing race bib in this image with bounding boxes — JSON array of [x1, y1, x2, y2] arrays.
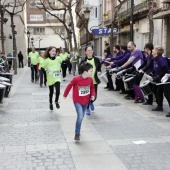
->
[[63, 62, 95, 140]]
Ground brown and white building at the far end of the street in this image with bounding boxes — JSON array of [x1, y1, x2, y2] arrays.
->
[[27, 0, 65, 50]]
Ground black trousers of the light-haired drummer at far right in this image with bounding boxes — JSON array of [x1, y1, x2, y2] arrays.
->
[[153, 84, 164, 107]]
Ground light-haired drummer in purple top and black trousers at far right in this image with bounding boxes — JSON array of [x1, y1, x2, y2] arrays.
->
[[152, 46, 169, 111]]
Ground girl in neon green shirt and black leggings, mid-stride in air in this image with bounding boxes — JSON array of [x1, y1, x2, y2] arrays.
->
[[43, 47, 62, 110]]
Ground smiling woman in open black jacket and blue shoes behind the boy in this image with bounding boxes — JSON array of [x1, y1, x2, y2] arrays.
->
[[80, 46, 101, 115]]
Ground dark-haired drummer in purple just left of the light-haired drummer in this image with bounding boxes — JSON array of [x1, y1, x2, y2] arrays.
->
[[138, 43, 155, 105]]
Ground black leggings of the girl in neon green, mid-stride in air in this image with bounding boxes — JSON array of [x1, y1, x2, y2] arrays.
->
[[49, 82, 60, 104]]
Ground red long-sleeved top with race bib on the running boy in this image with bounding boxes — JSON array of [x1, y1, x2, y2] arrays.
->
[[63, 76, 96, 105]]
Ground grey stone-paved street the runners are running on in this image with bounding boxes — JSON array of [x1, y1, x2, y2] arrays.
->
[[0, 67, 170, 170]]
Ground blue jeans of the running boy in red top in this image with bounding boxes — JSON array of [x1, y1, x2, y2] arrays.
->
[[74, 103, 87, 134]]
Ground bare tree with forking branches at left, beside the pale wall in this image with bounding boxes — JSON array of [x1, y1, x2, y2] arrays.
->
[[4, 0, 27, 74]]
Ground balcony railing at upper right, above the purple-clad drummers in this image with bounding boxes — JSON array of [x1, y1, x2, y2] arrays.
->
[[117, 1, 149, 20]]
